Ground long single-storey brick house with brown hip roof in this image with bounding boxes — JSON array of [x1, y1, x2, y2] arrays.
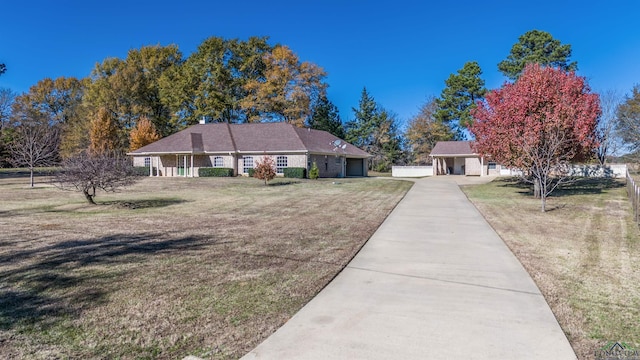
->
[[128, 121, 370, 177]]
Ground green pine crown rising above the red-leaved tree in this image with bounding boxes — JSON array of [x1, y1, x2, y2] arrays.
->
[[498, 30, 578, 80]]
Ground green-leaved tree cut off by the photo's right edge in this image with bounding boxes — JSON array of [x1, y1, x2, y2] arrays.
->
[[615, 85, 640, 155]]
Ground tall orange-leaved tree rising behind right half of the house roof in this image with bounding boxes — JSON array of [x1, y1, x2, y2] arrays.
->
[[241, 46, 327, 127]]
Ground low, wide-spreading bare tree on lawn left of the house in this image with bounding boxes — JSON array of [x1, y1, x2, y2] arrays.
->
[[56, 152, 137, 205]]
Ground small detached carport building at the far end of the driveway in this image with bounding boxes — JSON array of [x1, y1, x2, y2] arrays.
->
[[429, 141, 501, 176]]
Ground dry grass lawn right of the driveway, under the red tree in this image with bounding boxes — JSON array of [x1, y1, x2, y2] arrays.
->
[[463, 178, 640, 359]]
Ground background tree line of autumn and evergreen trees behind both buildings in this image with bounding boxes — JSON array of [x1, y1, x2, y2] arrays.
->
[[0, 30, 640, 176]]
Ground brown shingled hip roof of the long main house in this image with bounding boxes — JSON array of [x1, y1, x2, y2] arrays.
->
[[129, 123, 370, 158]]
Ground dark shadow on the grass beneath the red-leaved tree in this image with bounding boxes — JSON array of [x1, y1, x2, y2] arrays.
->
[[494, 177, 625, 197]]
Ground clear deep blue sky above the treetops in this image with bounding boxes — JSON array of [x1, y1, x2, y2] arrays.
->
[[0, 0, 640, 128]]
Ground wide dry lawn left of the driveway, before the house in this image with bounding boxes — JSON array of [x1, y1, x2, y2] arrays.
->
[[0, 174, 411, 359]]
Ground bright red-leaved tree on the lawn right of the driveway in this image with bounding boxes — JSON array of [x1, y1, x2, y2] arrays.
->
[[470, 64, 600, 212]]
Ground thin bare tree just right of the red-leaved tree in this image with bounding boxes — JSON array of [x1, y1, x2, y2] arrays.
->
[[596, 90, 622, 166]]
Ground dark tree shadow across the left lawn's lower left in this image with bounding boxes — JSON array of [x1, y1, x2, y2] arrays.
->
[[0, 233, 208, 332]]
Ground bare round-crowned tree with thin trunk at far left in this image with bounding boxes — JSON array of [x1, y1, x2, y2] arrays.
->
[[9, 121, 60, 187]]
